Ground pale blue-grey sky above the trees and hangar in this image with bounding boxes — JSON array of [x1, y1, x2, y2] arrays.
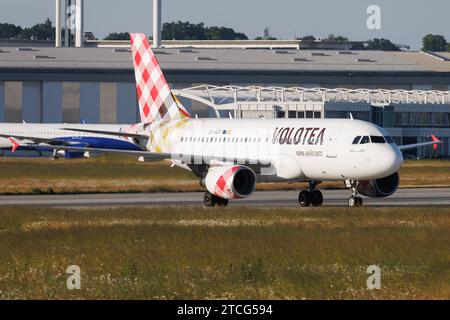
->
[[0, 0, 450, 50]]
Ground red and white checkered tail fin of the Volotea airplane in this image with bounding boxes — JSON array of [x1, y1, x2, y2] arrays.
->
[[130, 33, 189, 123]]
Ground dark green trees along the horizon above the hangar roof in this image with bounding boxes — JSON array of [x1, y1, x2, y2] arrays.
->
[[0, 18, 450, 51]]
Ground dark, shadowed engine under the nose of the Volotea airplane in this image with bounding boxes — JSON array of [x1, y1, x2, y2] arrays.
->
[[358, 172, 400, 198]]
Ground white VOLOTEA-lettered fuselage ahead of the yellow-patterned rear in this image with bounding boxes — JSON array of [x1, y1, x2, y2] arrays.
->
[[159, 119, 403, 181]]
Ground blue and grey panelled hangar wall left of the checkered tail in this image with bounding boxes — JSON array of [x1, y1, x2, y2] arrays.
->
[[0, 81, 138, 123]]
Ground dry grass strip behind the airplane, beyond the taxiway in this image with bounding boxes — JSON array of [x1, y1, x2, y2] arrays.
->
[[0, 156, 450, 194]]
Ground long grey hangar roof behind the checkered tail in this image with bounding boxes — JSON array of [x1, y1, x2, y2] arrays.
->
[[0, 47, 450, 85]]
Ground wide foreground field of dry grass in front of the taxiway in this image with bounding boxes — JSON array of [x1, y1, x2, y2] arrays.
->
[[0, 207, 450, 299]]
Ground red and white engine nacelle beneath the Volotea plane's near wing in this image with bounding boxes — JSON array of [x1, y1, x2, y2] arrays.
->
[[203, 165, 256, 199]]
